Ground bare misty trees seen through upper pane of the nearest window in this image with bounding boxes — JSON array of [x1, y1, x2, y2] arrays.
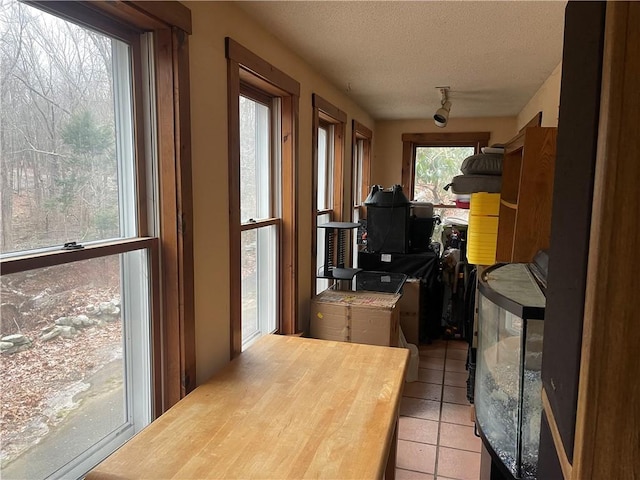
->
[[0, 0, 119, 253]]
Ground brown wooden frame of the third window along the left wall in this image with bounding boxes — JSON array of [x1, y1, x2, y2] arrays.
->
[[311, 93, 347, 297]]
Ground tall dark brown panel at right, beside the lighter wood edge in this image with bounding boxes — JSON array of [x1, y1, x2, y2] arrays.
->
[[541, 2, 604, 464]]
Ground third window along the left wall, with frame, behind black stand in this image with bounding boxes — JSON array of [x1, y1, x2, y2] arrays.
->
[[312, 94, 347, 294]]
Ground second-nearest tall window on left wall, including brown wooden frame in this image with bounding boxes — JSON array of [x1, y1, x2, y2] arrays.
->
[[227, 38, 300, 356]]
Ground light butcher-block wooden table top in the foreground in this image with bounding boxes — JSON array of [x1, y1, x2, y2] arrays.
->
[[86, 335, 409, 480]]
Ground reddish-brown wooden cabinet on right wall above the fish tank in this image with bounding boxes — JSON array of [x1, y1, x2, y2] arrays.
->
[[496, 127, 557, 263]]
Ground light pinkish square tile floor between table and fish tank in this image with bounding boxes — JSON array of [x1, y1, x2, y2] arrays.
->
[[396, 340, 480, 480]]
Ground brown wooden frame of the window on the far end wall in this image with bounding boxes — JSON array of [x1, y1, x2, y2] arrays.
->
[[402, 132, 491, 202]]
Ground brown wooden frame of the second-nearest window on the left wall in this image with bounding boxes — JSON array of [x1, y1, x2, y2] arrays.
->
[[225, 37, 300, 358]]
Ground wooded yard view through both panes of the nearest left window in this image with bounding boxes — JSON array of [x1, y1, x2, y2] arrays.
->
[[0, 2, 153, 478]]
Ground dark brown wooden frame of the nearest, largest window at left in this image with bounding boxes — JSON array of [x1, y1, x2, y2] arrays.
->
[[1, 0, 196, 418]]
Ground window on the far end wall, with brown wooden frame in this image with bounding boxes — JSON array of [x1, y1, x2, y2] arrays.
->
[[402, 132, 489, 249]]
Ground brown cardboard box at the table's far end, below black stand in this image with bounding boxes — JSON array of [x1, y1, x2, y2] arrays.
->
[[310, 290, 400, 347]]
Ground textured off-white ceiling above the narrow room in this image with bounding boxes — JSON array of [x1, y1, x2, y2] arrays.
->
[[238, 1, 566, 119]]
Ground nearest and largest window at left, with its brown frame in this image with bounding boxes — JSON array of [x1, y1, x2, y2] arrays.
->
[[0, 0, 193, 479]]
